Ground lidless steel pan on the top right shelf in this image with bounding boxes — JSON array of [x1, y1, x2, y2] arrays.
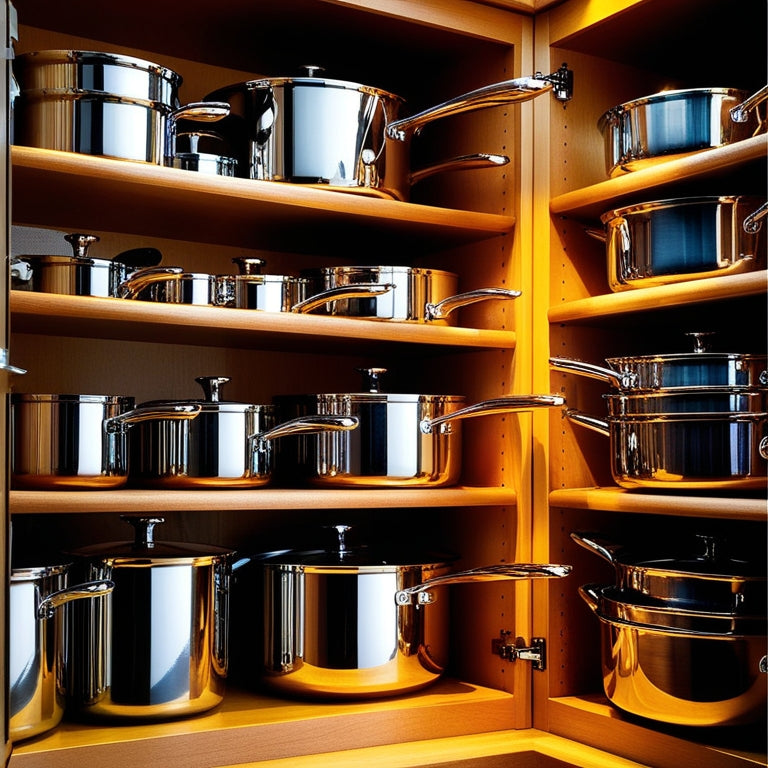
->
[[598, 86, 768, 177]]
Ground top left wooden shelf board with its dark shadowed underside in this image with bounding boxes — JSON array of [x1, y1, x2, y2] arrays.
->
[[11, 146, 514, 255]]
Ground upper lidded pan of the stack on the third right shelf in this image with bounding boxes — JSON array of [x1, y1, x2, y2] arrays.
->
[[549, 333, 768, 393]]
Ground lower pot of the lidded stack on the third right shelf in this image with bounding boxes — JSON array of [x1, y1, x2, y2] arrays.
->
[[565, 409, 768, 490]]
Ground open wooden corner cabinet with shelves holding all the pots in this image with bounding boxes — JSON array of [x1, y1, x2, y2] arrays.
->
[[9, 0, 766, 768]]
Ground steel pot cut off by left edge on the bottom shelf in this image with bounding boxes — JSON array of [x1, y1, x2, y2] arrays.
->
[[8, 563, 114, 741]]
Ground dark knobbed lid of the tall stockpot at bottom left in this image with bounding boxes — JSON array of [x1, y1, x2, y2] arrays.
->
[[72, 515, 234, 560]]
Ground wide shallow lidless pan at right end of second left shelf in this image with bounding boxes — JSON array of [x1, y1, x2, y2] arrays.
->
[[292, 266, 520, 325]]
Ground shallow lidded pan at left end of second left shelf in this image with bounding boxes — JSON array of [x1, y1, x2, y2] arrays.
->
[[11, 232, 162, 297]]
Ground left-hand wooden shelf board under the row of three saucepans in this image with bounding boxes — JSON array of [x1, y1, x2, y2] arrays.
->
[[9, 486, 516, 515]]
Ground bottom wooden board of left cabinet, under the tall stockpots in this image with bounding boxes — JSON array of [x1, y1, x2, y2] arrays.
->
[[10, 679, 514, 768]]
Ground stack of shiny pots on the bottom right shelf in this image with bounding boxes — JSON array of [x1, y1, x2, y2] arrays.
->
[[571, 533, 768, 726]]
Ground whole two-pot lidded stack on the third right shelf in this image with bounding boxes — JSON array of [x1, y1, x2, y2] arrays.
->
[[550, 334, 768, 490]]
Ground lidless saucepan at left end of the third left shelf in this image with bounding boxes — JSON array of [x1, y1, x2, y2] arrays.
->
[[10, 392, 197, 490]]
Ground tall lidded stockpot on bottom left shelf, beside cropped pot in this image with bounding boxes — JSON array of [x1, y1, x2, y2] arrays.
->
[[67, 516, 234, 719]]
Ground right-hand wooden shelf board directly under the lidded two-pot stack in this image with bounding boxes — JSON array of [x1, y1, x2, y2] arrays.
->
[[549, 488, 768, 522]]
